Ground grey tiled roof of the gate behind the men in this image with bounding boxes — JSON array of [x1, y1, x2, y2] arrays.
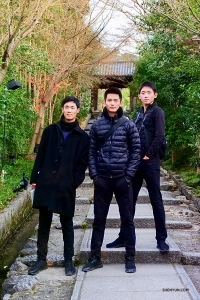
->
[[95, 60, 135, 76]]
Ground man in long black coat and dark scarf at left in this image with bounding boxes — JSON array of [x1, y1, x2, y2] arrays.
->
[[28, 96, 89, 276]]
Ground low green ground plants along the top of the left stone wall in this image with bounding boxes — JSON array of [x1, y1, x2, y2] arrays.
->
[[0, 158, 34, 210]]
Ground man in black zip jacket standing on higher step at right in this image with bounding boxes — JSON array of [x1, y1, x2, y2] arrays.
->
[[106, 81, 169, 253]]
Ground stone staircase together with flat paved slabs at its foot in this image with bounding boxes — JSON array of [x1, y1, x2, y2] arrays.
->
[[71, 170, 200, 300]]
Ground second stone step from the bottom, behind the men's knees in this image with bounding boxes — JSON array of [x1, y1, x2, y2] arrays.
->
[[86, 204, 192, 229]]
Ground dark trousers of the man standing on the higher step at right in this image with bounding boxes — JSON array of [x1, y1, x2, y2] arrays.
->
[[120, 157, 167, 240]]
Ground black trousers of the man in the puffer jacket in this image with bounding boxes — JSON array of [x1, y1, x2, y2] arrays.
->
[[91, 177, 135, 257]]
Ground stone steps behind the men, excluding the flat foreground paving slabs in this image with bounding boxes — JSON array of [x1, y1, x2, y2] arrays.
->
[[80, 173, 189, 264]]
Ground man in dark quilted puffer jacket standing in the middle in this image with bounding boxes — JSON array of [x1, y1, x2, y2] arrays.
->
[[82, 88, 140, 273]]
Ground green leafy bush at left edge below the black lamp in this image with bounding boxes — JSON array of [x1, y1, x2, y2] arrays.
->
[[0, 78, 35, 155]]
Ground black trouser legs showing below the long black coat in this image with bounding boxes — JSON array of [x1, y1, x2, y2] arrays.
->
[[37, 207, 74, 261]]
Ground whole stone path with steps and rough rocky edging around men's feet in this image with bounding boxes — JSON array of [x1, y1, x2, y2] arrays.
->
[[2, 171, 200, 300]]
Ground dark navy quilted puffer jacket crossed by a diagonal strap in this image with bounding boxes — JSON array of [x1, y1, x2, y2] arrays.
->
[[89, 108, 140, 178]]
